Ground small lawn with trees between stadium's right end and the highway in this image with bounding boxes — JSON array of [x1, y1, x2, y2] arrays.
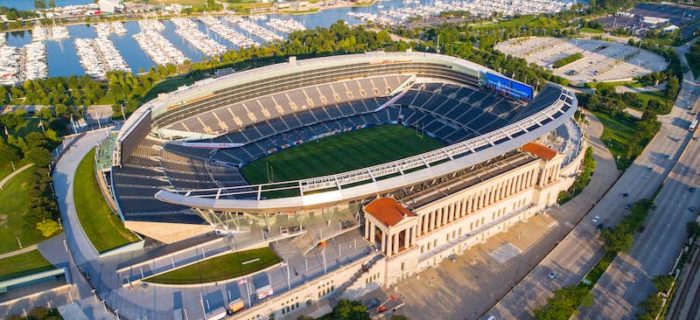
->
[[593, 111, 637, 168]]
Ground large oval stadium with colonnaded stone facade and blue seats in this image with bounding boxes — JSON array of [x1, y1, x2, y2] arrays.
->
[[109, 52, 584, 317]]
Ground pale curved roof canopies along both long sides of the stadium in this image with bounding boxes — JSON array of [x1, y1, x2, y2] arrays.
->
[[117, 52, 577, 212]]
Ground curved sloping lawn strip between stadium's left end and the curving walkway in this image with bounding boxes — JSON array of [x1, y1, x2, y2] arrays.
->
[[73, 149, 139, 253]]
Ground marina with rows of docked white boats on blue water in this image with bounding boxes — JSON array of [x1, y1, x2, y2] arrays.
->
[[0, 0, 571, 83]]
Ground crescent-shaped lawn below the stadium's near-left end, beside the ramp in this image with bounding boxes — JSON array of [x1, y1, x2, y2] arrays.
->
[[145, 248, 282, 284]]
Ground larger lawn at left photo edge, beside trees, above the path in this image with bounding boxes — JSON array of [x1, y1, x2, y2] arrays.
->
[[0, 167, 45, 253]]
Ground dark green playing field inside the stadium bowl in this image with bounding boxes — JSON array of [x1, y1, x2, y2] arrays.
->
[[242, 125, 444, 184]]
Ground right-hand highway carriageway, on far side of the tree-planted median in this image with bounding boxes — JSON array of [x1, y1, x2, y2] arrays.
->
[[578, 40, 700, 319]]
